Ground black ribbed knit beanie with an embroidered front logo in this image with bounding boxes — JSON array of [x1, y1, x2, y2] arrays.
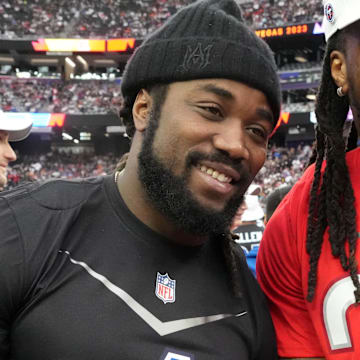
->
[[121, 0, 281, 125]]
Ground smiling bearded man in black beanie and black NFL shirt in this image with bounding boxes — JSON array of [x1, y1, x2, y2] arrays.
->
[[0, 0, 280, 360]]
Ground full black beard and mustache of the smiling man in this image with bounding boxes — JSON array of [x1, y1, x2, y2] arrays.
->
[[138, 106, 252, 236]]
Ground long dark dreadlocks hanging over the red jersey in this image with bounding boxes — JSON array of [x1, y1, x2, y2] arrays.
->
[[306, 30, 360, 303]]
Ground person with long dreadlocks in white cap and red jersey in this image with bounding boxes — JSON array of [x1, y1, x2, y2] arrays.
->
[[257, 0, 360, 360]]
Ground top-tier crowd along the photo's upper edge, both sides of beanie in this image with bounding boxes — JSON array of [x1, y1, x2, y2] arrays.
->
[[0, 0, 322, 39]]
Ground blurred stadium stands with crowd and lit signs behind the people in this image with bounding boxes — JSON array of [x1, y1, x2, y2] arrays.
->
[[0, 0, 325, 195]]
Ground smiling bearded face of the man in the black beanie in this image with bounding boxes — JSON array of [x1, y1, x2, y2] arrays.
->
[[139, 79, 274, 234]]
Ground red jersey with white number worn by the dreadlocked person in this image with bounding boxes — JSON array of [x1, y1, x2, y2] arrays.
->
[[256, 149, 360, 360]]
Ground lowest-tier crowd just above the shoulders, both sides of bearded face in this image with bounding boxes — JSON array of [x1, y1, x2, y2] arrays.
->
[[8, 145, 311, 200]]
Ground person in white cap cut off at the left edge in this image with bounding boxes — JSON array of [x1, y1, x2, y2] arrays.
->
[[0, 118, 32, 191]]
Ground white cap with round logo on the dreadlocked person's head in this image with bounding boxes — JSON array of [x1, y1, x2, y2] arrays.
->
[[323, 0, 360, 41]]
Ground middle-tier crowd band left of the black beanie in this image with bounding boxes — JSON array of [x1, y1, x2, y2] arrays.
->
[[0, 77, 122, 114]]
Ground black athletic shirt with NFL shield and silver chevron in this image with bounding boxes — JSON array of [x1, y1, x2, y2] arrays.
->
[[0, 176, 276, 360]]
